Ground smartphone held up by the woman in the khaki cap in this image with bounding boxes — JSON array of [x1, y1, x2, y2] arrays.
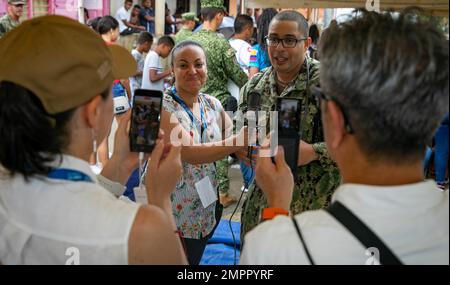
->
[[130, 89, 163, 153]]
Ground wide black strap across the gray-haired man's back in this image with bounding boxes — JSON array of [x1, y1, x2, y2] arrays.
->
[[327, 201, 402, 265]]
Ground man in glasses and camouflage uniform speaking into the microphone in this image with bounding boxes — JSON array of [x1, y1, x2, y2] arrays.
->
[[239, 11, 340, 240]]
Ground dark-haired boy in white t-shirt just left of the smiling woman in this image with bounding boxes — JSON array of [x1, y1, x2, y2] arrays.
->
[[142, 36, 175, 91]]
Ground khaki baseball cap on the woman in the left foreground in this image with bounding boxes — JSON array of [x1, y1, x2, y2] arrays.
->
[[0, 15, 137, 114]]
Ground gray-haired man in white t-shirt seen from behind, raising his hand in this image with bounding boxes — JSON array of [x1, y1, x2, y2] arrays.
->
[[241, 12, 449, 265]]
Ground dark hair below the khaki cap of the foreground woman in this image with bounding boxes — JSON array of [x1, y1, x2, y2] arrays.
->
[[0, 81, 109, 179]]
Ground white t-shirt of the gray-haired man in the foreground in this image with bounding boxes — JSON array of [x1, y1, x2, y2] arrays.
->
[[241, 181, 449, 265]]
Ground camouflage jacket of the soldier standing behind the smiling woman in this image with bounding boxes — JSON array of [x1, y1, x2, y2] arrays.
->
[[191, 29, 248, 105]]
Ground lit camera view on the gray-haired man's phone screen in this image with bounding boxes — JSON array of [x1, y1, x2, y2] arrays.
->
[[278, 99, 300, 134]]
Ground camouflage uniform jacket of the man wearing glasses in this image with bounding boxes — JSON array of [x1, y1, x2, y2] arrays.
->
[[239, 58, 340, 240]]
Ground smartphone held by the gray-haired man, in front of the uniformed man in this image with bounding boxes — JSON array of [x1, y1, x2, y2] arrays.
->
[[277, 98, 302, 178]]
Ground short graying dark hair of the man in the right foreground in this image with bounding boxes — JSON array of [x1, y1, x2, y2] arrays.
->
[[319, 11, 449, 164]]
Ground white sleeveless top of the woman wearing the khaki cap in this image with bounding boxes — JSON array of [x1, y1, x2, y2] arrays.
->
[[0, 155, 139, 265]]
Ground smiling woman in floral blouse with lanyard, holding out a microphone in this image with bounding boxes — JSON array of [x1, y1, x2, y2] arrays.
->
[[161, 41, 247, 264]]
